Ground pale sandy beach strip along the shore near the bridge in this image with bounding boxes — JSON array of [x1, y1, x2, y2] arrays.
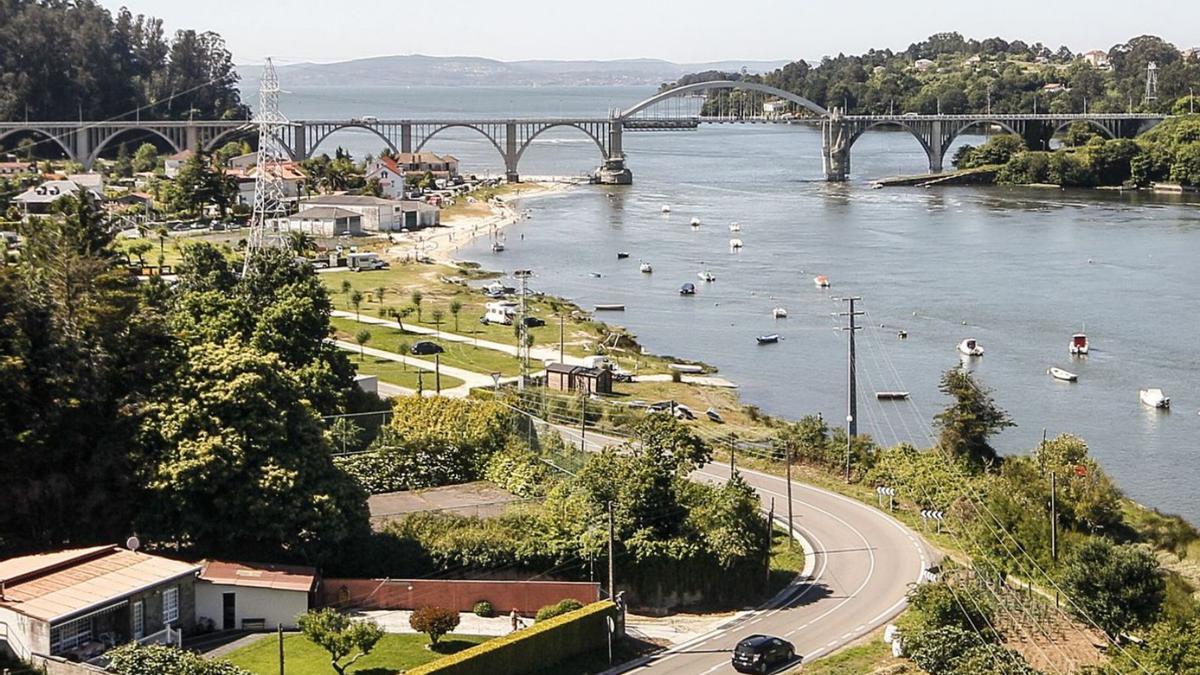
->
[[388, 177, 583, 263]]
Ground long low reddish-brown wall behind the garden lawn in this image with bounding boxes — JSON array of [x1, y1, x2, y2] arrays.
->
[[318, 579, 600, 615]]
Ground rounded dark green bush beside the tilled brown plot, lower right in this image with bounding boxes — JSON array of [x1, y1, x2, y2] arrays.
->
[[1062, 537, 1166, 638]]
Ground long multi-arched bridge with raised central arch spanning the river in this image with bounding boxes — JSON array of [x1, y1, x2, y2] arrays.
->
[[0, 80, 1164, 184]]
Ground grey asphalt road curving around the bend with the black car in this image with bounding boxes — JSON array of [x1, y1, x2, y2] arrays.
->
[[613, 464, 935, 675]]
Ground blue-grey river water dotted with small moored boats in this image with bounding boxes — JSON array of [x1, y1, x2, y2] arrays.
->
[[282, 83, 1200, 522]]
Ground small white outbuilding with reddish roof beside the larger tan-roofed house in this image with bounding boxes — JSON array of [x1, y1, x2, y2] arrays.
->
[[196, 561, 319, 631]]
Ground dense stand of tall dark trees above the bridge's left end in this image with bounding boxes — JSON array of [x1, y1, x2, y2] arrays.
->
[[0, 0, 247, 120]]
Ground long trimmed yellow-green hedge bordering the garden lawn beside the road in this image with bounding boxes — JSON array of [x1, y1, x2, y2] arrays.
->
[[408, 601, 617, 675]]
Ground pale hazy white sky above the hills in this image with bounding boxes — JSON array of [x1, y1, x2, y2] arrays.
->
[[102, 0, 1200, 64]]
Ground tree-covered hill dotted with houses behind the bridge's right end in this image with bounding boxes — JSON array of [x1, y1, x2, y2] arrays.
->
[[664, 32, 1200, 114]]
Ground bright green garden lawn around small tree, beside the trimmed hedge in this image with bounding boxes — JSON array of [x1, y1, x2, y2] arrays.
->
[[224, 633, 488, 675]]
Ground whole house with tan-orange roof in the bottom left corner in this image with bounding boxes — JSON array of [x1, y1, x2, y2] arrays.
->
[[0, 545, 200, 661]]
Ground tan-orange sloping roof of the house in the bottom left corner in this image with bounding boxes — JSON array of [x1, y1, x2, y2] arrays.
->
[[0, 545, 199, 621]]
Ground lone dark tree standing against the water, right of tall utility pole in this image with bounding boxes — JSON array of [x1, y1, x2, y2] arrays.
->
[[934, 368, 1015, 470]]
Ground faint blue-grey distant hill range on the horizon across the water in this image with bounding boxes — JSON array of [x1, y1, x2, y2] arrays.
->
[[239, 54, 787, 88]]
